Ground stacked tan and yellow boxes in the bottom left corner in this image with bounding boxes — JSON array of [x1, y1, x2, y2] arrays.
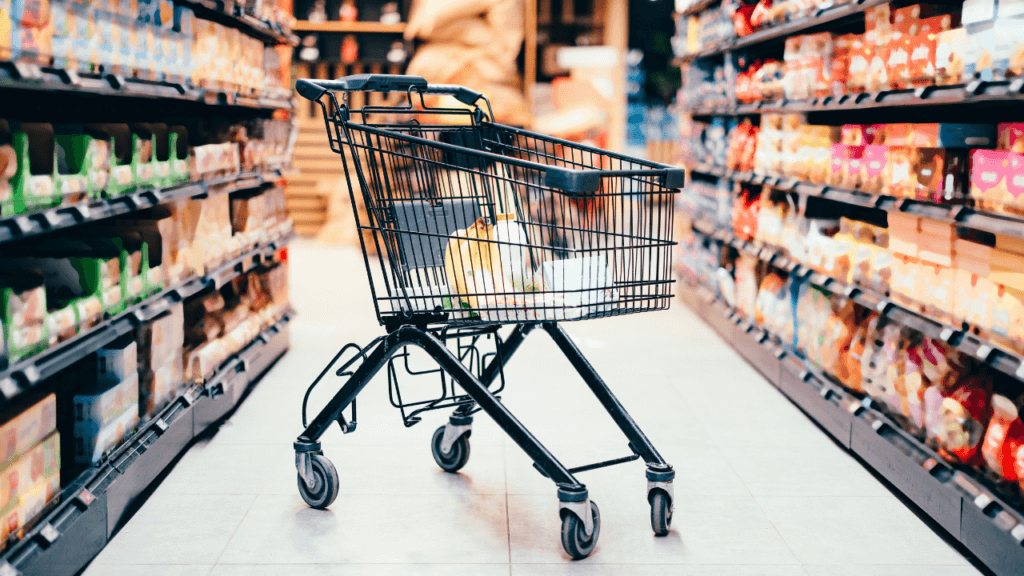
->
[[0, 395, 60, 548]]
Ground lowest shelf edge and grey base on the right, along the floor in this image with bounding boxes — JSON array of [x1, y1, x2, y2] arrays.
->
[[680, 285, 1024, 576]]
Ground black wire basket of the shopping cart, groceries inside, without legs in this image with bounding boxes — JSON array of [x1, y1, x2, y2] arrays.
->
[[336, 122, 677, 325]]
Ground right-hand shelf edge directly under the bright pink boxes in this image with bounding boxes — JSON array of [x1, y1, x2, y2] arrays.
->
[[689, 164, 1024, 238]]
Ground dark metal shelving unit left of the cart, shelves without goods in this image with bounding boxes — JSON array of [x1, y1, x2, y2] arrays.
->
[[0, 5, 297, 576]]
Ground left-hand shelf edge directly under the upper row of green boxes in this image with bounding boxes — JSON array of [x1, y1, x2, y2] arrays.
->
[[0, 169, 283, 244]]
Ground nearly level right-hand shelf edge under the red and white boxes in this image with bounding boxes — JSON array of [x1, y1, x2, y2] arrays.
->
[[689, 79, 1024, 116]]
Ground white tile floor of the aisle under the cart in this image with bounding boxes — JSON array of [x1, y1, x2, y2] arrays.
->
[[85, 242, 978, 576]]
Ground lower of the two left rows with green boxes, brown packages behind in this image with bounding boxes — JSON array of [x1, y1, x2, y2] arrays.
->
[[0, 188, 292, 367]]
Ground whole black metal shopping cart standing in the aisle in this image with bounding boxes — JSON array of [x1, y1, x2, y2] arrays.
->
[[294, 75, 684, 559]]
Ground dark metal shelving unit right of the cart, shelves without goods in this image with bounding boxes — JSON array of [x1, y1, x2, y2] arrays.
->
[[676, 0, 1024, 565]]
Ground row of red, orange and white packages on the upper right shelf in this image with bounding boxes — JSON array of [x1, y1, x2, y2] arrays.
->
[[677, 0, 1024, 98]]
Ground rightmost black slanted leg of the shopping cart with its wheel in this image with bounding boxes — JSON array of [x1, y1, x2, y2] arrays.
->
[[544, 322, 676, 535]]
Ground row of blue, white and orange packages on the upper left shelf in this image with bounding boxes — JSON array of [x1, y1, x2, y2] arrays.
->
[[0, 0, 291, 93]]
